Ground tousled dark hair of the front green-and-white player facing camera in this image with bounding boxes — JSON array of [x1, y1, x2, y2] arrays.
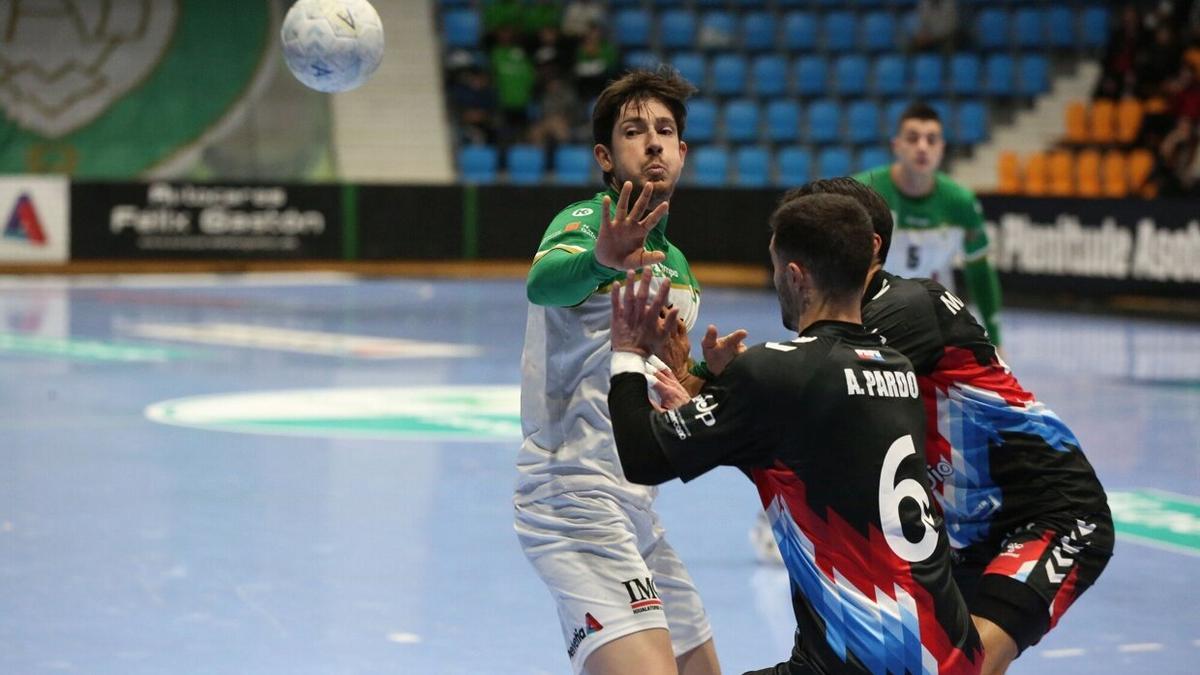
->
[[592, 65, 696, 185]]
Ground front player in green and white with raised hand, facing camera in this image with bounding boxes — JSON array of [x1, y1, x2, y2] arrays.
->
[[514, 71, 720, 675]]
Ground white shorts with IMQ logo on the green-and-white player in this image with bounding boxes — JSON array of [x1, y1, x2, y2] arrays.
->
[[516, 491, 713, 673]]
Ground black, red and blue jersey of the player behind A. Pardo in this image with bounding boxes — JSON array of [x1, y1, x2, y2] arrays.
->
[[863, 271, 1108, 549]]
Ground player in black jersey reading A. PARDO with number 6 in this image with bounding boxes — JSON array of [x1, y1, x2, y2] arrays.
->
[[608, 195, 983, 675]]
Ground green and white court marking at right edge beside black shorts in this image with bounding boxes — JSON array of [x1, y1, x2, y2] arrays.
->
[[1109, 490, 1200, 555]]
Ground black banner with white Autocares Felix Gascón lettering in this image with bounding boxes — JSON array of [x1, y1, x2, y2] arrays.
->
[[71, 183, 343, 261]]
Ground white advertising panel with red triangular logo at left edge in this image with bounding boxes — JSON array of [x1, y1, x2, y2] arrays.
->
[[0, 175, 71, 263]]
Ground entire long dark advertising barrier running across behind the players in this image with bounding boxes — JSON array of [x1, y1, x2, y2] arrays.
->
[[71, 183, 1200, 299]]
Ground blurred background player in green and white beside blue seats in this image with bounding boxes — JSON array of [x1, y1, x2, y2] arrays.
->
[[854, 103, 1001, 346]]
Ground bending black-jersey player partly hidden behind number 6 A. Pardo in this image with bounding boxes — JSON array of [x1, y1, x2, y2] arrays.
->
[[782, 178, 1114, 673]]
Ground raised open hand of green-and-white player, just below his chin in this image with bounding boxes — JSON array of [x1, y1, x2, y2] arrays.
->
[[595, 180, 668, 269]]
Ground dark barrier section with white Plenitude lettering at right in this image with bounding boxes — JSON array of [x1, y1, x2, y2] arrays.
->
[[980, 197, 1200, 299]]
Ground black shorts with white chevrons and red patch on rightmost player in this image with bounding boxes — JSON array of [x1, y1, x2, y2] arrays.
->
[[954, 512, 1114, 651]]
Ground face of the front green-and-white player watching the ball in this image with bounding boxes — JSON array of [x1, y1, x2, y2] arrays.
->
[[595, 98, 688, 202]]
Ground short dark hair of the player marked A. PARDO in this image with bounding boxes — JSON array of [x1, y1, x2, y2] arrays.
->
[[770, 195, 872, 300]]
